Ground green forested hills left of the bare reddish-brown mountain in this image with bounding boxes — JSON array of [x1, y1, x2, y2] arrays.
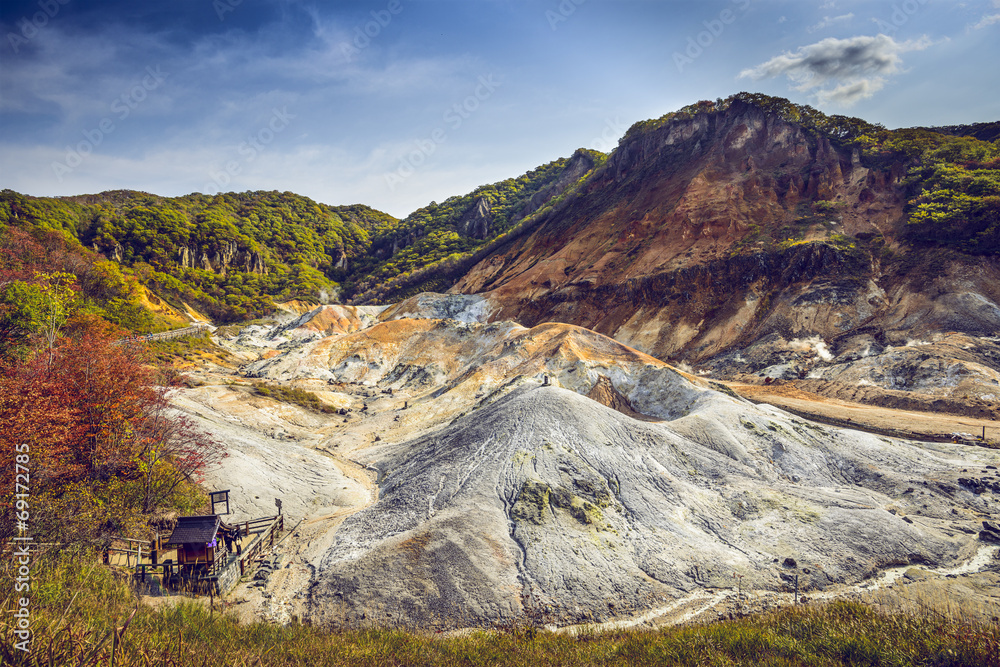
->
[[0, 151, 604, 321]]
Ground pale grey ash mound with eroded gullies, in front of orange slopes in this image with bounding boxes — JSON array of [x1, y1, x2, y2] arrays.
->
[[309, 384, 1000, 627]]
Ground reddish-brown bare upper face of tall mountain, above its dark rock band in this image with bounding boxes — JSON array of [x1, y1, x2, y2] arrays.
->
[[453, 104, 903, 332]]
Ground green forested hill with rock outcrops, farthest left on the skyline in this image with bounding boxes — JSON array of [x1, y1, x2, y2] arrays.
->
[[0, 191, 397, 320]]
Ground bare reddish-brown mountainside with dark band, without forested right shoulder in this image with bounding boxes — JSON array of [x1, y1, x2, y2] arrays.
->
[[452, 101, 1000, 412]]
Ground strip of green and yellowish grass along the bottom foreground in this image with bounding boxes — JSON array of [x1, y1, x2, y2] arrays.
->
[[0, 554, 1000, 667]]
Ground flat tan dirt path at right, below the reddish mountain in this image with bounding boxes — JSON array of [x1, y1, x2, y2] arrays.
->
[[724, 382, 1000, 446]]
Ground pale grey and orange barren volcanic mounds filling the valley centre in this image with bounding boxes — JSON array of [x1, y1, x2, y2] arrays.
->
[[184, 298, 1000, 627]]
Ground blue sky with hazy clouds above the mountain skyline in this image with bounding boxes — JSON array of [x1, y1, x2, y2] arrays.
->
[[0, 0, 1000, 216]]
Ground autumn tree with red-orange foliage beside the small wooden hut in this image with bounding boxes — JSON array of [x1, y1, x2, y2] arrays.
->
[[0, 314, 223, 542]]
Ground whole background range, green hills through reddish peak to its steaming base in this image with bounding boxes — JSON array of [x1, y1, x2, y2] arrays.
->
[[7, 93, 1000, 416]]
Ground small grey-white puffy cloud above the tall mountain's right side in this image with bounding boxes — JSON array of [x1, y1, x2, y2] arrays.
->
[[739, 35, 931, 105]]
